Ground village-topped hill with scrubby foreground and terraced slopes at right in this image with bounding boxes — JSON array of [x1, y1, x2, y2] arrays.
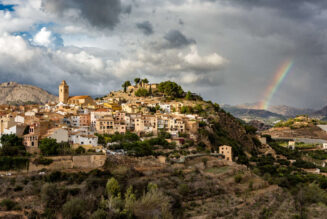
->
[[0, 81, 327, 219]]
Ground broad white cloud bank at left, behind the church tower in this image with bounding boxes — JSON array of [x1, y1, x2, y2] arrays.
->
[[0, 34, 120, 95]]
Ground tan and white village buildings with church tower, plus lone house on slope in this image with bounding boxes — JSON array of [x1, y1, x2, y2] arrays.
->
[[0, 79, 232, 161]]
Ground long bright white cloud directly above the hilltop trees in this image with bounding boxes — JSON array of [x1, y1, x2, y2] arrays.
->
[[113, 45, 227, 83]]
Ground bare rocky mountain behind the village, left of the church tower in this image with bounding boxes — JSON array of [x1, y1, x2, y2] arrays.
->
[[0, 82, 58, 104]]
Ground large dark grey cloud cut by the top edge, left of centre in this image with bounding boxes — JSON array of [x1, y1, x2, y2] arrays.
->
[[42, 0, 123, 29]]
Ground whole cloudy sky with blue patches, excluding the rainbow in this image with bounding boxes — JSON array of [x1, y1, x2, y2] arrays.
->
[[0, 0, 327, 108]]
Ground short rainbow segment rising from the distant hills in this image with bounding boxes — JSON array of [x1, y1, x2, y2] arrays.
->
[[259, 59, 293, 110]]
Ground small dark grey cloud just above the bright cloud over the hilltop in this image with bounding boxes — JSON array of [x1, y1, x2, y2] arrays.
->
[[164, 30, 196, 48]]
